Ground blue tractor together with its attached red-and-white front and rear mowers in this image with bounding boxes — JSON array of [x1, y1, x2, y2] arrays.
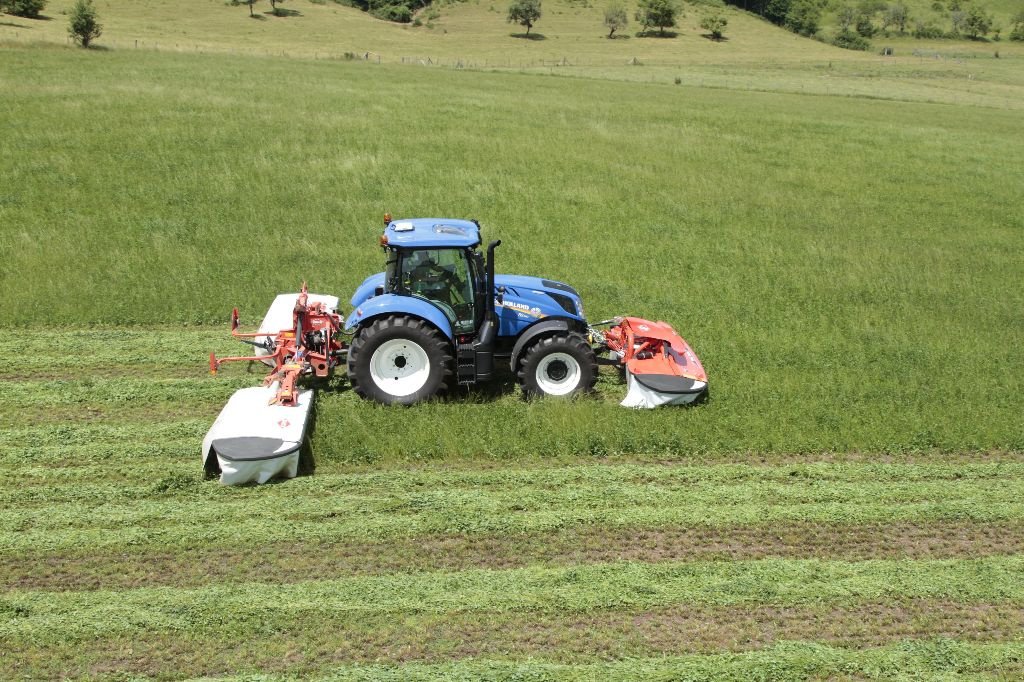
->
[[202, 216, 708, 484]]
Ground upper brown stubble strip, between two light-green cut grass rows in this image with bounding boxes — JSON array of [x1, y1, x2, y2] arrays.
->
[[8, 522, 1024, 591]]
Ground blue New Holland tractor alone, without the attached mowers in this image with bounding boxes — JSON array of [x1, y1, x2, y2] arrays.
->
[[345, 216, 599, 404]]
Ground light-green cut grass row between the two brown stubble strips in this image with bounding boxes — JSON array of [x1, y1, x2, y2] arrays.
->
[[6, 556, 1024, 646]]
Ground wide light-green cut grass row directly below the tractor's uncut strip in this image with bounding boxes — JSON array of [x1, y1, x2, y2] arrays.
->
[[0, 450, 1024, 554]]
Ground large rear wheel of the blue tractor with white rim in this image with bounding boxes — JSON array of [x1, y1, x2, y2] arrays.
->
[[348, 315, 452, 404]]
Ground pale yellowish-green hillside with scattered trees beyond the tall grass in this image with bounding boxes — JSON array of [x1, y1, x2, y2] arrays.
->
[[0, 0, 1024, 100]]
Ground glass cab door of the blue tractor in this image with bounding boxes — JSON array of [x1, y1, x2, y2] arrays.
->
[[397, 249, 479, 334]]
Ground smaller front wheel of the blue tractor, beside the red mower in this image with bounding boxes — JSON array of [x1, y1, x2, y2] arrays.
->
[[518, 333, 597, 397]]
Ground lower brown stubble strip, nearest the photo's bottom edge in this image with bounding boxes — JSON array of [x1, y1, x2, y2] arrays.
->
[[0, 599, 1024, 677]]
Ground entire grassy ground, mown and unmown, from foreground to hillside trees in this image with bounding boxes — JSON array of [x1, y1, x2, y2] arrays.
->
[[0, 0, 1024, 680]]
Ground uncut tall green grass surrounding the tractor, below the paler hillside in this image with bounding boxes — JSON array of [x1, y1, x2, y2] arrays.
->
[[0, 48, 1024, 454]]
